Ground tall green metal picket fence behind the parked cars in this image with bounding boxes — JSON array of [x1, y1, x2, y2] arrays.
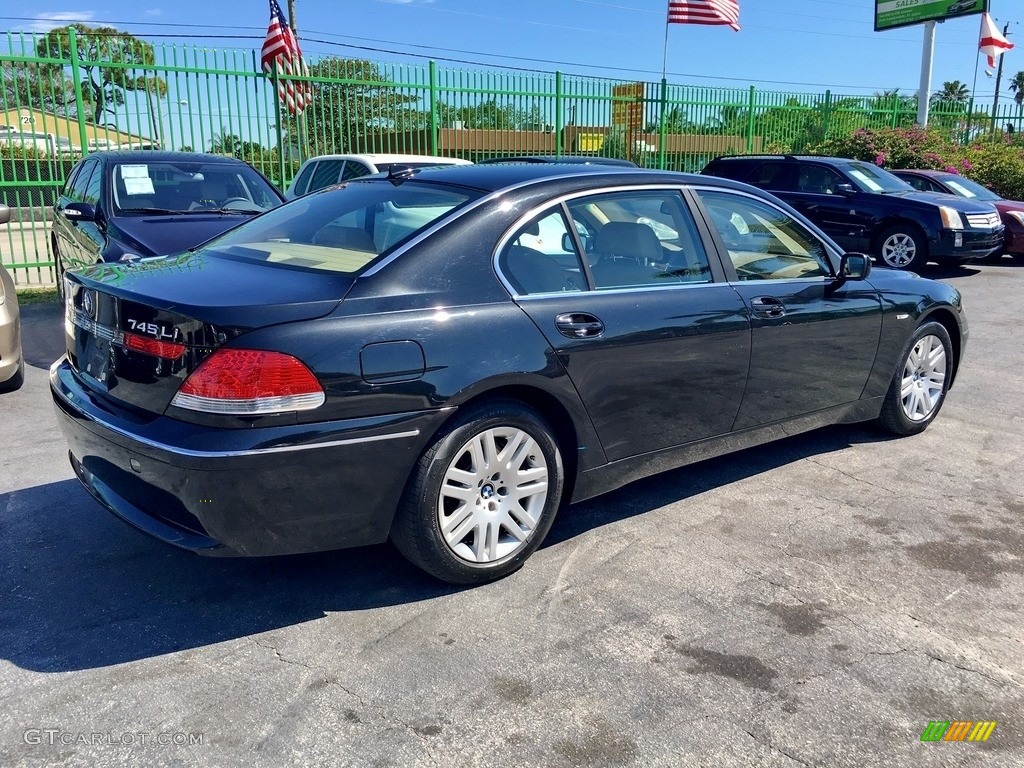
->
[[0, 29, 1020, 285]]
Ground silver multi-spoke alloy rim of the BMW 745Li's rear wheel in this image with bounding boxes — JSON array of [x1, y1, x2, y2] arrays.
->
[[437, 427, 549, 563]]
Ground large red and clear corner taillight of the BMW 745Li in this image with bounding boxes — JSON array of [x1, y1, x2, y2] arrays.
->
[[171, 349, 324, 415]]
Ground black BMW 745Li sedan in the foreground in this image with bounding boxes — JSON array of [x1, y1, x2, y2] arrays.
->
[[50, 164, 967, 584]]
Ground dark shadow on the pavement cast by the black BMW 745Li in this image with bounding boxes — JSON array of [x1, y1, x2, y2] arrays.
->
[[0, 427, 884, 672]]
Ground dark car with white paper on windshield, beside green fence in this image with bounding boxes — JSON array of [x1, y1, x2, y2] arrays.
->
[[50, 151, 285, 288]]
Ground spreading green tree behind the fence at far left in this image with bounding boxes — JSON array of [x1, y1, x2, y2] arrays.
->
[[36, 24, 167, 124]]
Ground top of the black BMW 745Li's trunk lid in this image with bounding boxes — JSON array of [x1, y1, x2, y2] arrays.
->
[[70, 251, 354, 329]]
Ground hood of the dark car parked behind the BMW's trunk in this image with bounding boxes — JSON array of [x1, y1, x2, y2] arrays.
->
[[111, 213, 252, 256]]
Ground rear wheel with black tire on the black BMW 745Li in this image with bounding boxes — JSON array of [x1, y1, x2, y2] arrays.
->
[[391, 400, 564, 584]]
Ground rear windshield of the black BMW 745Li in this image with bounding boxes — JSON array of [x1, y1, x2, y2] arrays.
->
[[201, 179, 480, 274]]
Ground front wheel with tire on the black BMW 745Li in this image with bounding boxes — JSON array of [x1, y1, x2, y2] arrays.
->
[[879, 323, 953, 435]]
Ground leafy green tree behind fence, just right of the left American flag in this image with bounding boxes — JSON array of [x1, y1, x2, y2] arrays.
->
[[294, 56, 426, 155]]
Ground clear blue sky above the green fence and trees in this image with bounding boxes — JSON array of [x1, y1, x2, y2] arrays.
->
[[0, 0, 1024, 98]]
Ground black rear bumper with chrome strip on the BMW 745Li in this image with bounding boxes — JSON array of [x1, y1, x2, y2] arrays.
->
[[50, 359, 450, 556]]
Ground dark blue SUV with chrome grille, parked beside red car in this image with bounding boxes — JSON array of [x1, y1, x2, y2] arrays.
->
[[701, 155, 1004, 269]]
